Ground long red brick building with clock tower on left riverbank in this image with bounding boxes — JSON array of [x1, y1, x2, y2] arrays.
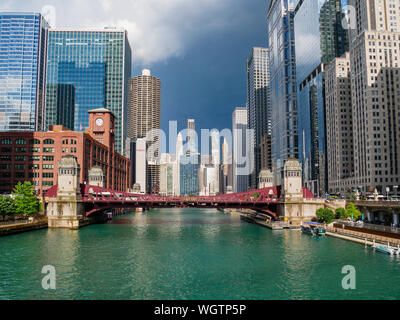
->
[[0, 109, 131, 195]]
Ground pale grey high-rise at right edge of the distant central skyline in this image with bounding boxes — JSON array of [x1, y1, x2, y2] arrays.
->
[[232, 108, 250, 193]]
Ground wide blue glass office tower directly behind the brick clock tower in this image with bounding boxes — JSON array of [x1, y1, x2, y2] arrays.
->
[[44, 29, 131, 153]]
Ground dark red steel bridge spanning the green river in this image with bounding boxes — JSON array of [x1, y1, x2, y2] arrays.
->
[[46, 185, 314, 219]]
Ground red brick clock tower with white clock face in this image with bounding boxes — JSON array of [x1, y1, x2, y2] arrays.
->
[[86, 108, 115, 150]]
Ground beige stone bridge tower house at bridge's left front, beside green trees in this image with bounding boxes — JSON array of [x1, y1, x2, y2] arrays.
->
[[46, 156, 85, 229]]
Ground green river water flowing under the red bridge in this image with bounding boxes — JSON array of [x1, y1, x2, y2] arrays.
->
[[0, 209, 400, 300]]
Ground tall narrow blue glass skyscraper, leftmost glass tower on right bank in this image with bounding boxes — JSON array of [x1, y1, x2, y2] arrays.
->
[[267, 0, 299, 172]]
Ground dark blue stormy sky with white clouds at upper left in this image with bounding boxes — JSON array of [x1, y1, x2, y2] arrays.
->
[[0, 0, 268, 142]]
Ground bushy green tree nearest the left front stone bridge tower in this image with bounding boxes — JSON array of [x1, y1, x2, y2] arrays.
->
[[13, 181, 40, 216]]
